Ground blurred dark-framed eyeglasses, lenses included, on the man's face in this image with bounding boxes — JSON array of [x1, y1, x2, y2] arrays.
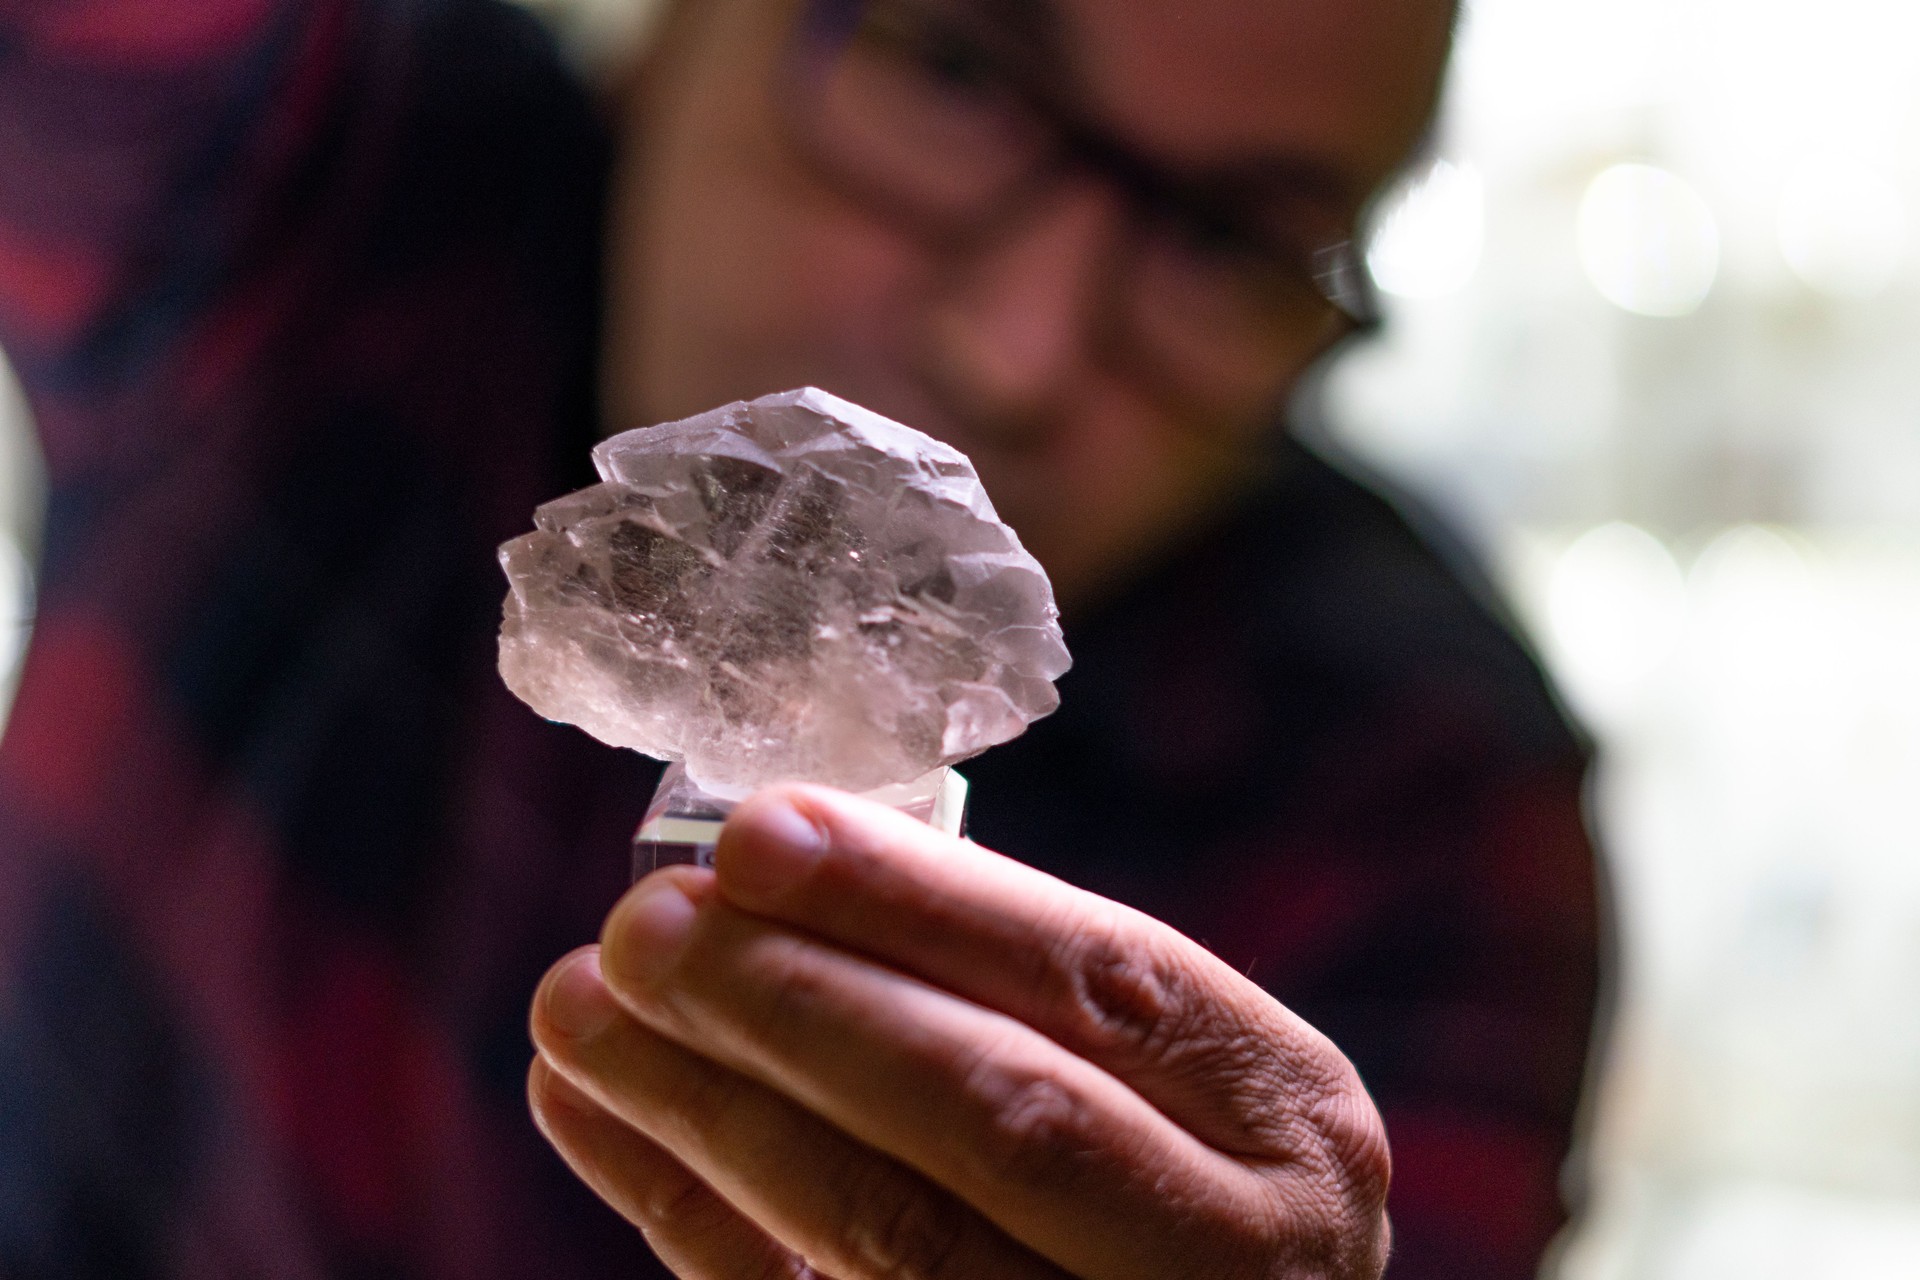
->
[[787, 0, 1380, 416]]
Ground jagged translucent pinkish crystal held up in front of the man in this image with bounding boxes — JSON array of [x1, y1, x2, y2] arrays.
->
[[499, 388, 1068, 796]]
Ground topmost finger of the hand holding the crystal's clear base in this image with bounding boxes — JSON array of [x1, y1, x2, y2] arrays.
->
[[714, 785, 1384, 1180]]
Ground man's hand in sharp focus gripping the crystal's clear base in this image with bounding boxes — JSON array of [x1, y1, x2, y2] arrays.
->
[[528, 787, 1388, 1280]]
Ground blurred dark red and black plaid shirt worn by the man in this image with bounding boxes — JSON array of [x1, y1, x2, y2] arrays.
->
[[0, 0, 1599, 1280]]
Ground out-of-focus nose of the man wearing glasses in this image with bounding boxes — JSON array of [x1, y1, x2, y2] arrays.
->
[[924, 178, 1125, 445]]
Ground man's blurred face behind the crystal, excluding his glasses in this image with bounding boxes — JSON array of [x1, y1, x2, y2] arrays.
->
[[603, 0, 1450, 604]]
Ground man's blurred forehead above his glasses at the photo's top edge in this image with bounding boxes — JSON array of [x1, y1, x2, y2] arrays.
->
[[1052, 0, 1452, 201]]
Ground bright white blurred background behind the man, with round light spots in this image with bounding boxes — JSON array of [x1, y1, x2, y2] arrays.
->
[[0, 0, 1920, 1280]]
